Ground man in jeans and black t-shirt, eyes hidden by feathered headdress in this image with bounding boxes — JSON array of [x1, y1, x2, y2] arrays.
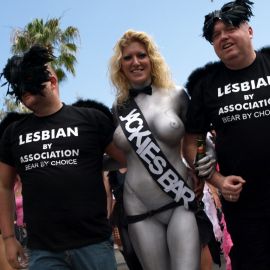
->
[[0, 46, 125, 270]]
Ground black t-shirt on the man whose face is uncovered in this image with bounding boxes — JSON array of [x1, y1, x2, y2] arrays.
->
[[186, 52, 270, 217]]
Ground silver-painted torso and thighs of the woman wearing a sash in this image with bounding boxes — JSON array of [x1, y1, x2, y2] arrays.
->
[[114, 86, 200, 270]]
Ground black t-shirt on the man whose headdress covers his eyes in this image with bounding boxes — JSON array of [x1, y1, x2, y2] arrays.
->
[[0, 105, 114, 250]]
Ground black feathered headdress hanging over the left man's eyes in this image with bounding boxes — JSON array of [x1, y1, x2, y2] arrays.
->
[[0, 45, 55, 99]]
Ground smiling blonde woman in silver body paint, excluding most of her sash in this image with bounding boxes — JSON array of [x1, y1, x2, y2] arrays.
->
[[110, 30, 200, 270]]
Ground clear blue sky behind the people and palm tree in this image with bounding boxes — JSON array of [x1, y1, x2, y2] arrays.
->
[[0, 0, 270, 107]]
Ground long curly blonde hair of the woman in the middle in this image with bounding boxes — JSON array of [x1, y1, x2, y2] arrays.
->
[[109, 30, 175, 104]]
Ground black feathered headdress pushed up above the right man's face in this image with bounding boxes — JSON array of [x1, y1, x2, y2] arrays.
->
[[203, 0, 253, 43]]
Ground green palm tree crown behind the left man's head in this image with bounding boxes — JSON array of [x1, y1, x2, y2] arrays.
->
[[11, 17, 79, 82]]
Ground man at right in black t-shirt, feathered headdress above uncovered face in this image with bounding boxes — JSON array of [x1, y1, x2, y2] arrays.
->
[[183, 0, 270, 270]]
